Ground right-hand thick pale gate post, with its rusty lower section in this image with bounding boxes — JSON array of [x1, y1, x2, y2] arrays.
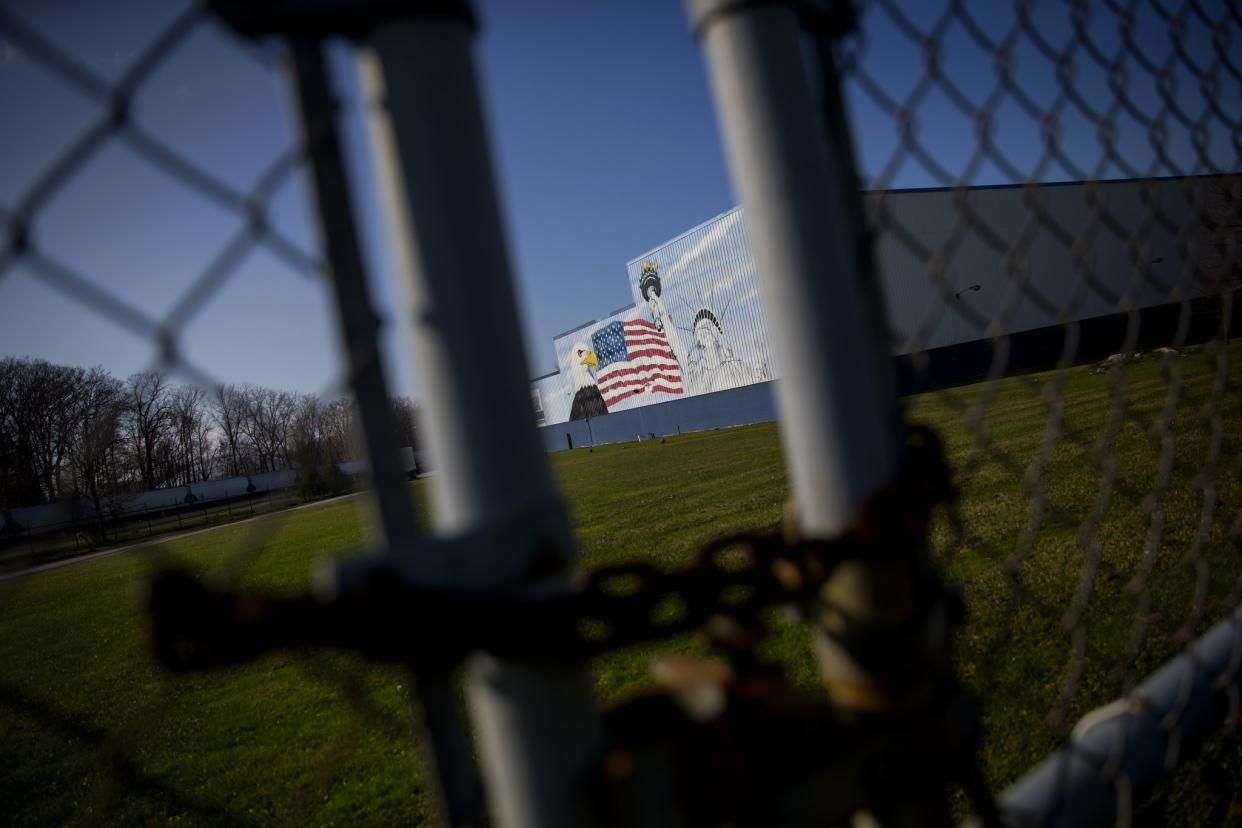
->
[[687, 0, 978, 824]]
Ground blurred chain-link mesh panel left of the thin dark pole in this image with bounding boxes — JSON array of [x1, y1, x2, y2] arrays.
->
[[0, 4, 430, 824]]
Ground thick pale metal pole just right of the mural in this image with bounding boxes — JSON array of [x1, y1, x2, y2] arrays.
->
[[688, 0, 917, 709]]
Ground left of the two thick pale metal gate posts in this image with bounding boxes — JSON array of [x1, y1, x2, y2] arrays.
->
[[360, 8, 601, 826]]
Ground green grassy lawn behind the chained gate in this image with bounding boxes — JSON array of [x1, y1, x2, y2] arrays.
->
[[0, 344, 1242, 824]]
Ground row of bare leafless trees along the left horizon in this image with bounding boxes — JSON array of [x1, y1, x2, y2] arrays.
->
[[0, 358, 417, 510]]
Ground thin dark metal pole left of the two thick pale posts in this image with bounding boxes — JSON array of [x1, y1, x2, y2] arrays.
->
[[281, 37, 484, 826]]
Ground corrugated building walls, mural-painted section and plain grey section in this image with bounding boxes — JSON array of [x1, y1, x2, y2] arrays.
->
[[532, 179, 1207, 427]]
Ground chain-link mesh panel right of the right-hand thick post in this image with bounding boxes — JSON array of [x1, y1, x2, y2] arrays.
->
[[841, 0, 1242, 822]]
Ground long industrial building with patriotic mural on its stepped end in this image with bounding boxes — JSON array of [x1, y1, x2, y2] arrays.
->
[[532, 176, 1237, 449]]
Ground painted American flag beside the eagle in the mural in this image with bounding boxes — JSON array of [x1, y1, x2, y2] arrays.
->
[[591, 319, 684, 408]]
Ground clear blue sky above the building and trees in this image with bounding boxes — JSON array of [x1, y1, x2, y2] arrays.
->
[[0, 0, 1242, 395]]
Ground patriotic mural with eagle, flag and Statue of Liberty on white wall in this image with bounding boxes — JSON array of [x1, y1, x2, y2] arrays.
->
[[534, 210, 775, 423]]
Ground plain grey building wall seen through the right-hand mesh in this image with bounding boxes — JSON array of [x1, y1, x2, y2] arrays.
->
[[866, 179, 1206, 354]]
